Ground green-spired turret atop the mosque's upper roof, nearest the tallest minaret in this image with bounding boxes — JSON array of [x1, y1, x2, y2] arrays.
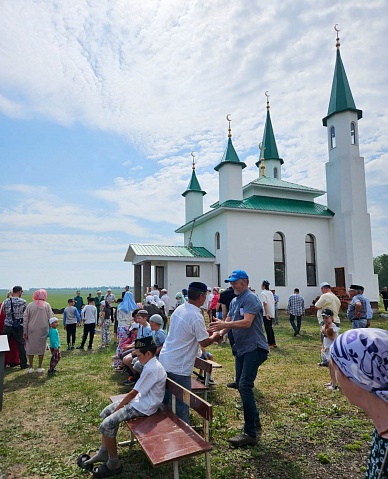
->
[[256, 92, 284, 180]]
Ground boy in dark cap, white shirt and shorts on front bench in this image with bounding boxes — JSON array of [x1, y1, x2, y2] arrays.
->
[[77, 336, 167, 478]]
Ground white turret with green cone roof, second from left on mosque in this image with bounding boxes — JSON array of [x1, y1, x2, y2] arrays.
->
[[214, 115, 247, 204]]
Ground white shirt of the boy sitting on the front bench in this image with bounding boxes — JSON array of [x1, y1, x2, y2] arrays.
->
[[130, 357, 167, 416]]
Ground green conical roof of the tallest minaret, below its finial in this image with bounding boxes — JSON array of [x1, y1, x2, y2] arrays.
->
[[322, 48, 362, 126]]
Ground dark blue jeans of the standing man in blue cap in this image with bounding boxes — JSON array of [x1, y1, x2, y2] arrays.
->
[[236, 348, 268, 437]]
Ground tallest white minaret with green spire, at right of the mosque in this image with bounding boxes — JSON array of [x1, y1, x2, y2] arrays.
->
[[322, 26, 378, 301]]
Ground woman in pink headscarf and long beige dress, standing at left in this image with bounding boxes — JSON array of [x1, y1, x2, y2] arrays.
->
[[23, 289, 54, 374]]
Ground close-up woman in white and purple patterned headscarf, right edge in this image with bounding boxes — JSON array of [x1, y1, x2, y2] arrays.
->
[[330, 328, 388, 479]]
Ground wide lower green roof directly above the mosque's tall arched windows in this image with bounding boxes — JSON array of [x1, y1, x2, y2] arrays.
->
[[212, 195, 334, 217]]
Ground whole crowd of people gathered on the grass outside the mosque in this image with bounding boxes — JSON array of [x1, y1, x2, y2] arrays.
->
[[0, 280, 388, 478]]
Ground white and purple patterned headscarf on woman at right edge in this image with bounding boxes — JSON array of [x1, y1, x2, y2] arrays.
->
[[330, 328, 388, 402]]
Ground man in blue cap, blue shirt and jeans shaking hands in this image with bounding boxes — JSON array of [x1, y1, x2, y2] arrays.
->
[[209, 269, 269, 446]]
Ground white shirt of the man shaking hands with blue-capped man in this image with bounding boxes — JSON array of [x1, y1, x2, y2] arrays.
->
[[159, 303, 209, 376]]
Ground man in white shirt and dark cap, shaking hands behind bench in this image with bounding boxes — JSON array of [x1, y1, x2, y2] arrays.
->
[[159, 281, 222, 423]]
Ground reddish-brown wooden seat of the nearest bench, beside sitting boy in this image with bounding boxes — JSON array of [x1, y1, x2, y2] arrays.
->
[[127, 411, 212, 466]]
